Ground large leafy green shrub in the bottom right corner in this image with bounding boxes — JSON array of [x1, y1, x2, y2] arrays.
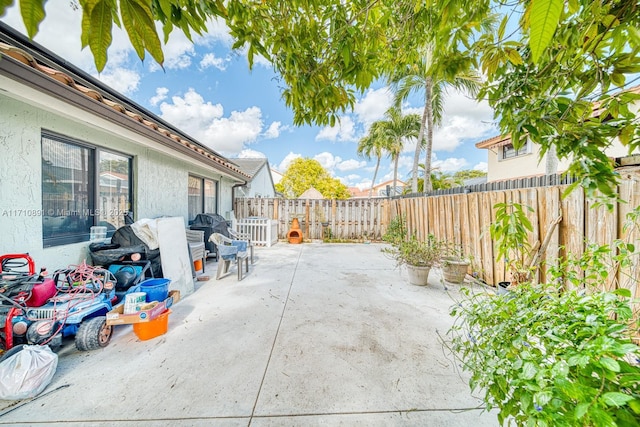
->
[[449, 284, 640, 427]]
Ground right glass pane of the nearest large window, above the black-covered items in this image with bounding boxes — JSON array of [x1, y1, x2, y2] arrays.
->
[[96, 151, 132, 232]]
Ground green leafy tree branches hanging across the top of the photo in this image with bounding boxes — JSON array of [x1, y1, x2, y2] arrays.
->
[[5, 0, 640, 201]]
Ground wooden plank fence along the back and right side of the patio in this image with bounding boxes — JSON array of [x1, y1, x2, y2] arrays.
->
[[235, 167, 640, 297]]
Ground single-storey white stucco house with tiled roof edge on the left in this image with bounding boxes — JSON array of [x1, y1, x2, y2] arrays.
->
[[0, 23, 249, 270]]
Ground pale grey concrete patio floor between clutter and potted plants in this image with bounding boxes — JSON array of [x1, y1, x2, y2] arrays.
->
[[0, 242, 499, 427]]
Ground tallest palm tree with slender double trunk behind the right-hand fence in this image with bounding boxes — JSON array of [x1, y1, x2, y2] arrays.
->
[[390, 43, 480, 192]]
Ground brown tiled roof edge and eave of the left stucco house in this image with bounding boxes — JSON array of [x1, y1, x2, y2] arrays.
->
[[0, 22, 249, 181]]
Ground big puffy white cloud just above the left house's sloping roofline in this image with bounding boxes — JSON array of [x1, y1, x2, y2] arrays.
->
[[160, 89, 262, 155]]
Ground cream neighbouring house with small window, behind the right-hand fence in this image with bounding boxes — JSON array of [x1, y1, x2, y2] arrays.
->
[[476, 86, 640, 182]]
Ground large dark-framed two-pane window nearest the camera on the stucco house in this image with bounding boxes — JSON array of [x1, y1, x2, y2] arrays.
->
[[42, 134, 132, 247]]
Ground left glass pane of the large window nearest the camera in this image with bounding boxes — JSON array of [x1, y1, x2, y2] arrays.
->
[[42, 136, 94, 247]]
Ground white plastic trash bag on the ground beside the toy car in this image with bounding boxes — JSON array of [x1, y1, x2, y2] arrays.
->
[[0, 345, 58, 400]]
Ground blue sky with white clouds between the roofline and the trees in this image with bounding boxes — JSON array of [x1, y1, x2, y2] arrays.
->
[[0, 2, 498, 188]]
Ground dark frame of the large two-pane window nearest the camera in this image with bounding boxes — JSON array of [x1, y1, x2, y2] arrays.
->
[[40, 130, 135, 248]]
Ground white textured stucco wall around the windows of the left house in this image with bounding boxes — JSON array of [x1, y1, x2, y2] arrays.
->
[[0, 92, 231, 271]]
